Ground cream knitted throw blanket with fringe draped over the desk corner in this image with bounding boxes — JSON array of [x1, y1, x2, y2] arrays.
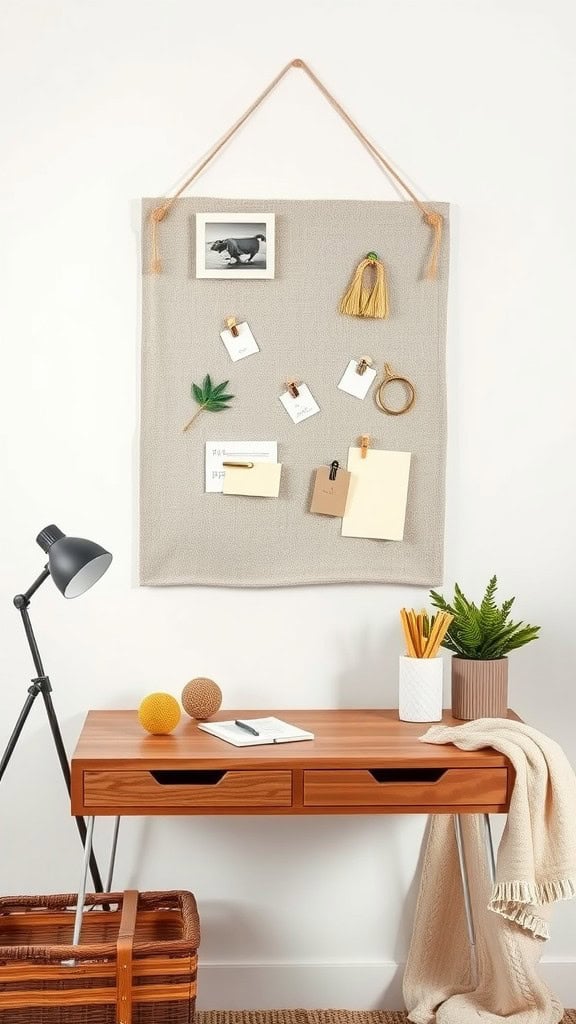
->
[[404, 719, 576, 1024]]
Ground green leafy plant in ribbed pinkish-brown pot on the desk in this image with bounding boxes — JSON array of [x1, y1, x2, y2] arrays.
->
[[430, 575, 540, 721]]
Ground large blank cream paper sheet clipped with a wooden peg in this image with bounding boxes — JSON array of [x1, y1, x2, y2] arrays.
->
[[342, 447, 411, 541]]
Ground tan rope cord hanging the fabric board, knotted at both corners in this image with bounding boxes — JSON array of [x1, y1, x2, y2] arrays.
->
[[150, 57, 443, 278]]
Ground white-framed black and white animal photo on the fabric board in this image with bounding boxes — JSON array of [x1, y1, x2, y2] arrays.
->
[[196, 214, 274, 278]]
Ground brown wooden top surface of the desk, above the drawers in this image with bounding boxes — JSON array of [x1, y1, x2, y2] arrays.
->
[[72, 708, 510, 774]]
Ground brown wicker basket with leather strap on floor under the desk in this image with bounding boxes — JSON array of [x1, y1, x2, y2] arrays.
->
[[0, 892, 200, 1024]]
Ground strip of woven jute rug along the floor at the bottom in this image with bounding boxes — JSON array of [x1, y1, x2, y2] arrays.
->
[[196, 1010, 576, 1024]]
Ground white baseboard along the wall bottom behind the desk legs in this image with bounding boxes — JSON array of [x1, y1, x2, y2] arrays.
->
[[197, 957, 576, 1010]]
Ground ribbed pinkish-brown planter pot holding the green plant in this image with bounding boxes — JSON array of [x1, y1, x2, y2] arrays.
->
[[452, 655, 508, 721]]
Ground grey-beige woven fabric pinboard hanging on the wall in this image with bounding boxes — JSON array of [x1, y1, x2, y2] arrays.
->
[[139, 198, 449, 587]]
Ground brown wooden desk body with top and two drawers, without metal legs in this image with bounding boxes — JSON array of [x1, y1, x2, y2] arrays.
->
[[72, 710, 511, 817]]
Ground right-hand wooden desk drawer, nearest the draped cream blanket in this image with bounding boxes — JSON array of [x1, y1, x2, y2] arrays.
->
[[304, 767, 507, 808]]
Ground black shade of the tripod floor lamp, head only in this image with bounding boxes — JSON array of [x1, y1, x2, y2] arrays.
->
[[36, 524, 112, 598]]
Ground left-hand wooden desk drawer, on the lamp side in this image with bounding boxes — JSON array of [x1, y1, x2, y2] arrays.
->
[[84, 770, 292, 812]]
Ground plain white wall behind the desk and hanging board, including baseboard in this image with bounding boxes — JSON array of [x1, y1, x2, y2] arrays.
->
[[0, 0, 576, 1007]]
